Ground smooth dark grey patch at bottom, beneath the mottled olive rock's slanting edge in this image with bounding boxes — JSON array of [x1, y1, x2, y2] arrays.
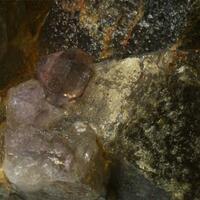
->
[[110, 161, 171, 200]]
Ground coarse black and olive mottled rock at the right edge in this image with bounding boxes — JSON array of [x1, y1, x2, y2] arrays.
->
[[116, 51, 200, 199]]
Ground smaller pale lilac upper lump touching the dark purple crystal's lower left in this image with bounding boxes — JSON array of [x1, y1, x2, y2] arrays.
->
[[6, 80, 64, 128]]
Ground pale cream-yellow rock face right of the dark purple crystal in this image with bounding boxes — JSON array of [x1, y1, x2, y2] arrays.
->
[[59, 58, 141, 143]]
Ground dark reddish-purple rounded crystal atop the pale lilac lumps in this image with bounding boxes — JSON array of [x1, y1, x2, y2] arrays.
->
[[37, 49, 92, 106]]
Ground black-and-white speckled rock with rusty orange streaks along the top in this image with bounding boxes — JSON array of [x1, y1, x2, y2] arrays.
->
[[43, 0, 193, 59]]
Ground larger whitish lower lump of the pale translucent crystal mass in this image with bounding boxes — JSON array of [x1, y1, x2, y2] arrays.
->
[[3, 125, 106, 195]]
